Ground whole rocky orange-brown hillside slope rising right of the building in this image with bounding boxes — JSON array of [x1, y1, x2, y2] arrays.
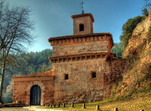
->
[[112, 11, 151, 97]]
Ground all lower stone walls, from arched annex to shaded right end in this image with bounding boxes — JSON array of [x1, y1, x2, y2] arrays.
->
[[13, 57, 129, 105]]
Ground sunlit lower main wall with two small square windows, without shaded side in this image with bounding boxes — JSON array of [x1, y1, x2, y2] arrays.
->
[[53, 58, 109, 103]]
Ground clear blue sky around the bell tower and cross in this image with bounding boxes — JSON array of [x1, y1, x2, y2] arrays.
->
[[5, 0, 145, 52]]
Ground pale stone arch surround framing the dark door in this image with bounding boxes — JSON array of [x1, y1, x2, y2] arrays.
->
[[27, 81, 45, 105]]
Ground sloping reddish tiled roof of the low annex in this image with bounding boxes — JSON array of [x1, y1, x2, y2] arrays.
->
[[14, 70, 54, 78]]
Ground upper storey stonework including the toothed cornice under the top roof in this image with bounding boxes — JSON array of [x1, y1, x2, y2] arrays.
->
[[49, 33, 113, 56]]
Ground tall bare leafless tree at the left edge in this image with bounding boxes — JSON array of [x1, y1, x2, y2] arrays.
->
[[0, 2, 33, 101]]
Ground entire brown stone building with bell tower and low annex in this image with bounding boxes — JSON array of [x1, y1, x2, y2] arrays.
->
[[13, 13, 124, 105]]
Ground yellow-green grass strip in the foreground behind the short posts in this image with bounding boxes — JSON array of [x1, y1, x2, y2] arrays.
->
[[40, 92, 151, 111]]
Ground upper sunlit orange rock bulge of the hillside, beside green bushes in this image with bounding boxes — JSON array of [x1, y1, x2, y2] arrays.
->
[[123, 8, 151, 58]]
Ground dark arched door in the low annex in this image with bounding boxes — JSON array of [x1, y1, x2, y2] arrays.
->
[[30, 85, 41, 105]]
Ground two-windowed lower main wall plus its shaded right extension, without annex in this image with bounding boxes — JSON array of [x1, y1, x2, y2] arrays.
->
[[53, 58, 128, 103]]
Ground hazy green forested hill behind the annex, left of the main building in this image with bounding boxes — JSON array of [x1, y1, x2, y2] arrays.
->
[[3, 49, 52, 103]]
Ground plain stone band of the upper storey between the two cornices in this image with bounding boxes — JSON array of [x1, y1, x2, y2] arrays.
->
[[52, 39, 108, 56]]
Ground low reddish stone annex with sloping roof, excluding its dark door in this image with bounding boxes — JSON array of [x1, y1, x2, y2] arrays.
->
[[13, 71, 54, 105]]
